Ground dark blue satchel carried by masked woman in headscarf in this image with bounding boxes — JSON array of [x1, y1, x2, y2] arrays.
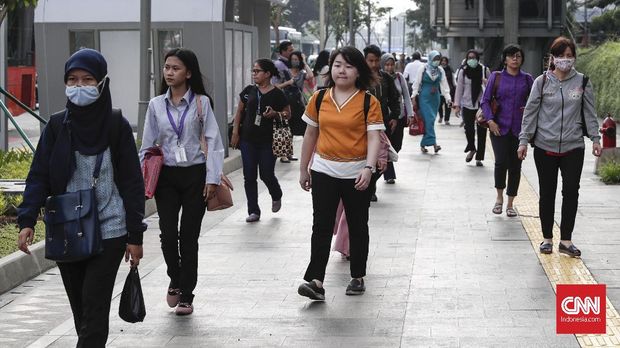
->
[[44, 154, 103, 262]]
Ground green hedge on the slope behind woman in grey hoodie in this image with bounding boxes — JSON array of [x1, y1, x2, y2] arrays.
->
[[577, 41, 620, 117]]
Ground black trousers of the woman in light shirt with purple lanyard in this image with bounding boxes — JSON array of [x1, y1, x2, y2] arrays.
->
[[155, 164, 206, 303]]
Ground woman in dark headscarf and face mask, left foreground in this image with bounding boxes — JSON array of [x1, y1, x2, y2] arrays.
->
[[17, 49, 146, 347]]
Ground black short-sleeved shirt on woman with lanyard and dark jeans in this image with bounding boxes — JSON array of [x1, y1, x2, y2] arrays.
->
[[239, 85, 288, 144]]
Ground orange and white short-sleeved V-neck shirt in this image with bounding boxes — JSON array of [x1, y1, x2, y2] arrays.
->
[[303, 88, 385, 179]]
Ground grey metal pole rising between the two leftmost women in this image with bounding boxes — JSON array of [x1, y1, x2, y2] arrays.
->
[[138, 0, 151, 141]]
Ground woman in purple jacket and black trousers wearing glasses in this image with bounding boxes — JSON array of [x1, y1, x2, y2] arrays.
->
[[481, 44, 533, 217]]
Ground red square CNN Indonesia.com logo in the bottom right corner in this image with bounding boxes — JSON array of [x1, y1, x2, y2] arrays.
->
[[555, 284, 607, 334]]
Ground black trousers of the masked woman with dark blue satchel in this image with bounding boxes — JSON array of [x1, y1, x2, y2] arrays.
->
[[57, 236, 127, 348]]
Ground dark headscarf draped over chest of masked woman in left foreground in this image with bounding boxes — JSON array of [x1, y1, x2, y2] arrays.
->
[[50, 49, 112, 192]]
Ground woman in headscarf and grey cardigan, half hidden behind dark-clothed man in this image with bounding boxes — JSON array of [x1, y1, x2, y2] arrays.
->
[[381, 53, 413, 184]]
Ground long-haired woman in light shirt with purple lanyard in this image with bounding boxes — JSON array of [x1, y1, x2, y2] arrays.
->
[[140, 48, 224, 315]]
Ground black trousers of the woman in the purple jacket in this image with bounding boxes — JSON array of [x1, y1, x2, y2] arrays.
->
[[491, 133, 521, 197]]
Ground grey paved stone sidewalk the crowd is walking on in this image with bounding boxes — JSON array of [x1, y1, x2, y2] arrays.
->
[[0, 121, 620, 347]]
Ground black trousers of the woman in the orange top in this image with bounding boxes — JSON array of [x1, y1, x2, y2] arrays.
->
[[304, 171, 370, 281]]
